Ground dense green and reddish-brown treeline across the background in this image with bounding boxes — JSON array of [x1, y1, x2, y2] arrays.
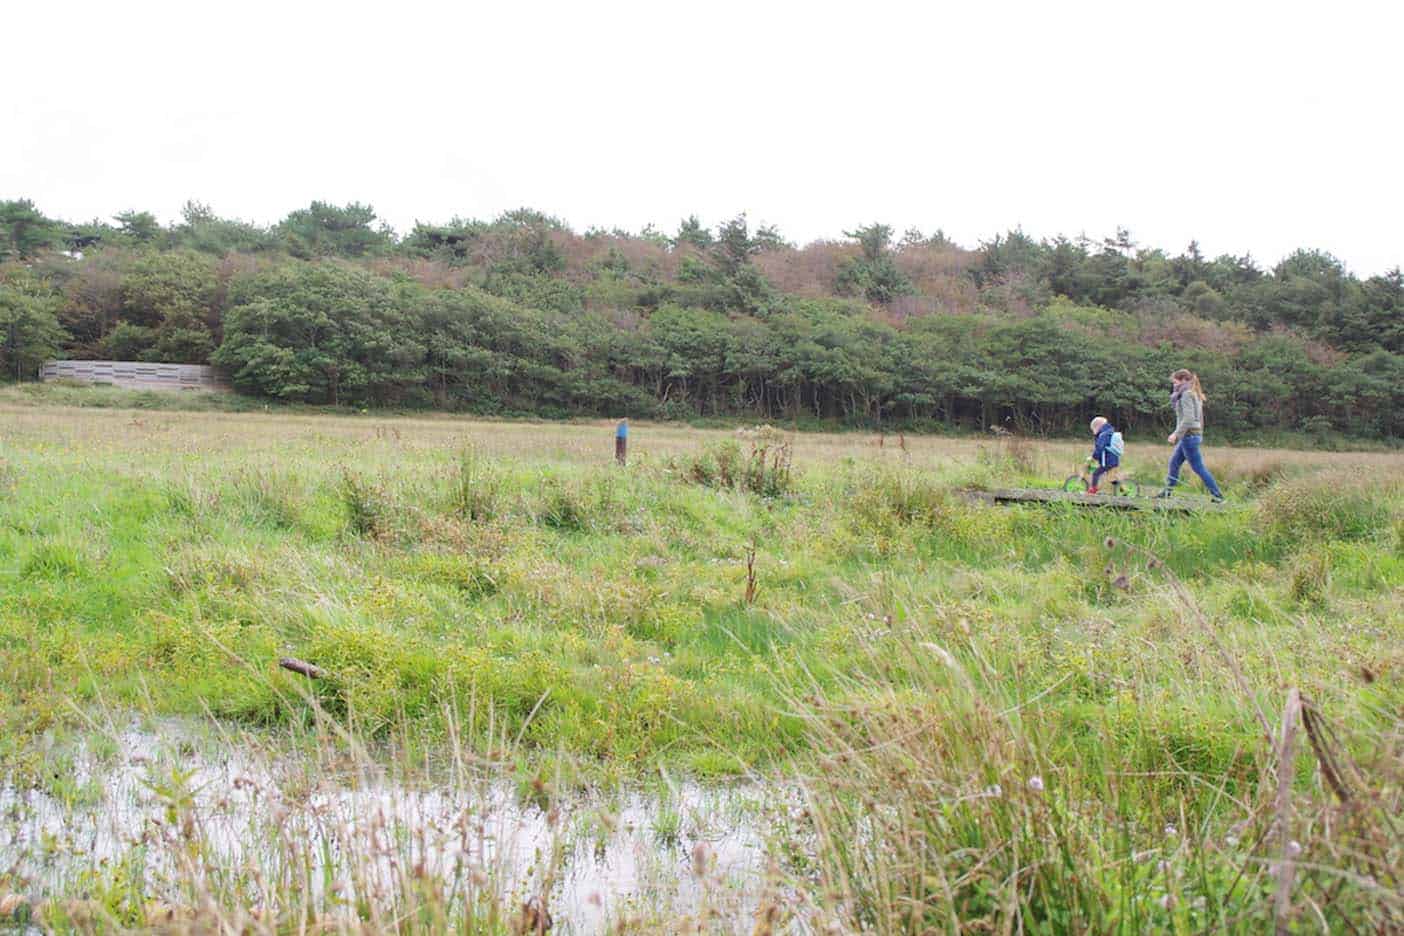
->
[[0, 201, 1404, 438]]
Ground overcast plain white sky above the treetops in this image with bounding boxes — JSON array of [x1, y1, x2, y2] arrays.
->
[[0, 0, 1404, 275]]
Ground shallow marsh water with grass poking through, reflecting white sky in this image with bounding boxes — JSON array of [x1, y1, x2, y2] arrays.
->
[[0, 723, 775, 933]]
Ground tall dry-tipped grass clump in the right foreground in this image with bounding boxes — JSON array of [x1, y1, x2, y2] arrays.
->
[[793, 560, 1404, 933]]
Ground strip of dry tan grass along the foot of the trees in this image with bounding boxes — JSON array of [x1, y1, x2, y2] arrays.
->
[[0, 399, 1404, 484]]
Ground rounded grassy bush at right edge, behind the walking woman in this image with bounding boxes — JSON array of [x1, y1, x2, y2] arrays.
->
[[1255, 472, 1398, 544]]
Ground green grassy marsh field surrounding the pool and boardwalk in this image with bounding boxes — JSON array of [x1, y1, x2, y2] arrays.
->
[[0, 394, 1404, 933]]
